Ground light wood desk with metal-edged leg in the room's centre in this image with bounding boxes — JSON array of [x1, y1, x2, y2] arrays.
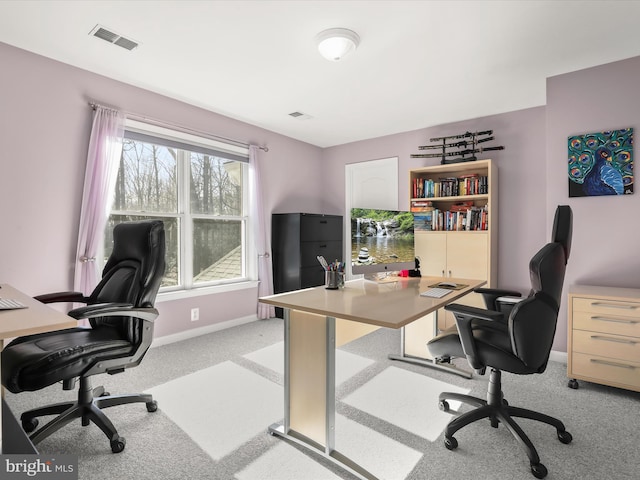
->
[[259, 277, 485, 480]]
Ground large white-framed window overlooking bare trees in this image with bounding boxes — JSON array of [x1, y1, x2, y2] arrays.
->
[[104, 120, 252, 291]]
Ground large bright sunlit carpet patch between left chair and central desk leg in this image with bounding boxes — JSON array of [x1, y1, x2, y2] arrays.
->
[[148, 362, 284, 460]]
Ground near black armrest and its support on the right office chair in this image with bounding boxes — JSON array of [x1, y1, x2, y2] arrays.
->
[[444, 303, 506, 373]]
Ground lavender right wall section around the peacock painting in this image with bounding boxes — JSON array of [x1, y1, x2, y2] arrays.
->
[[545, 57, 640, 351]]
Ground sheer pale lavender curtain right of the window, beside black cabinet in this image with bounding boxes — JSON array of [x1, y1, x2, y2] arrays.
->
[[249, 145, 275, 320]]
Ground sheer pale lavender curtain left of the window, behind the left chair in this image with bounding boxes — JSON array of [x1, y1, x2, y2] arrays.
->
[[74, 106, 124, 295]]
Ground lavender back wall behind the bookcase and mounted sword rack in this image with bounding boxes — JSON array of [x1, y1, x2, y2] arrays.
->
[[324, 107, 547, 304]]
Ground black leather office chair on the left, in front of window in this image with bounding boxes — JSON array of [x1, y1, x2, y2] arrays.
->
[[2, 220, 165, 453]]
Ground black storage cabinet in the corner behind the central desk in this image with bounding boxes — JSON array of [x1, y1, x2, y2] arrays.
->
[[271, 213, 343, 317]]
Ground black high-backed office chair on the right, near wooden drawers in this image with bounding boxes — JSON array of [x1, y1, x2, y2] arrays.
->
[[428, 206, 572, 478]]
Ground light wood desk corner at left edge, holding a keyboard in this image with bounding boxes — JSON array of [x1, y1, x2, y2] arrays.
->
[[0, 283, 78, 453]]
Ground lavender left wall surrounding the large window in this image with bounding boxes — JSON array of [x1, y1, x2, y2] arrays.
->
[[0, 43, 322, 336]]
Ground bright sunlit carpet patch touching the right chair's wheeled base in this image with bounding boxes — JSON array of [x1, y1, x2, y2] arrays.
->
[[342, 367, 469, 442]]
